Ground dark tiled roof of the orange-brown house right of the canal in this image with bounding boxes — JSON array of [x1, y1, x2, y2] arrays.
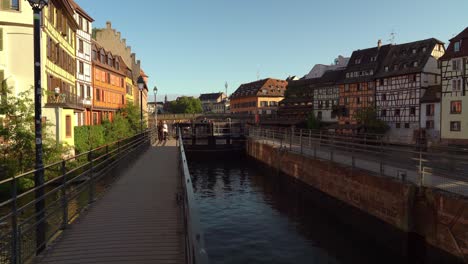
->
[[343, 44, 391, 83]]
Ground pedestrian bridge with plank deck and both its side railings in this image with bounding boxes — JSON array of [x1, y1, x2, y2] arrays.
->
[[0, 132, 208, 264]]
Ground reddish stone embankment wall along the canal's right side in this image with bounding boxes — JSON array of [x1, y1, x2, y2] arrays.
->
[[247, 140, 468, 263]]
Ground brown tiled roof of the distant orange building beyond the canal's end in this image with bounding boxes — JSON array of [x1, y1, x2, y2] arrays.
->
[[231, 78, 288, 99]]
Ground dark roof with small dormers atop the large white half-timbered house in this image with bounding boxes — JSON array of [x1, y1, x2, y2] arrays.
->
[[375, 38, 444, 78]]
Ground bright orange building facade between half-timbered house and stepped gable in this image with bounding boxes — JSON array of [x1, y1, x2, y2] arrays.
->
[[86, 41, 127, 125]]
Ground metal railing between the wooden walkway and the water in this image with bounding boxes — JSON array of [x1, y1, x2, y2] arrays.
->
[[177, 128, 208, 264]]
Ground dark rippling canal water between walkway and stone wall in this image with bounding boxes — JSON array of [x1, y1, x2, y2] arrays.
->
[[189, 156, 407, 264]]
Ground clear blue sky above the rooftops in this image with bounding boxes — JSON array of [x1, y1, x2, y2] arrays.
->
[[76, 0, 468, 100]]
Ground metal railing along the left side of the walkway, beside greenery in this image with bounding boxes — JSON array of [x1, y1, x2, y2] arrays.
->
[[0, 131, 153, 264]]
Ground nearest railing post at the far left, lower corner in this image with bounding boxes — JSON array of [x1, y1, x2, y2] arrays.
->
[[10, 177, 21, 264]]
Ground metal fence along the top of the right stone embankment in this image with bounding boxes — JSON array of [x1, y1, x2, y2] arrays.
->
[[249, 127, 468, 196]]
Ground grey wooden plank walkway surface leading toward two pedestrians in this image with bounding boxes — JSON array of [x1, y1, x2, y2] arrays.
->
[[36, 141, 185, 264]]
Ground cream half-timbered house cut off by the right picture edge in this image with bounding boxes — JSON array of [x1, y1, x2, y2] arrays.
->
[[440, 27, 468, 145]]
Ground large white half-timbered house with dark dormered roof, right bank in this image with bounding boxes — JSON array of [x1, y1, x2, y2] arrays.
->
[[375, 38, 444, 143]]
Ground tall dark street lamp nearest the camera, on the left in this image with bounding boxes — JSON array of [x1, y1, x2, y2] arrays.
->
[[28, 0, 48, 253]]
